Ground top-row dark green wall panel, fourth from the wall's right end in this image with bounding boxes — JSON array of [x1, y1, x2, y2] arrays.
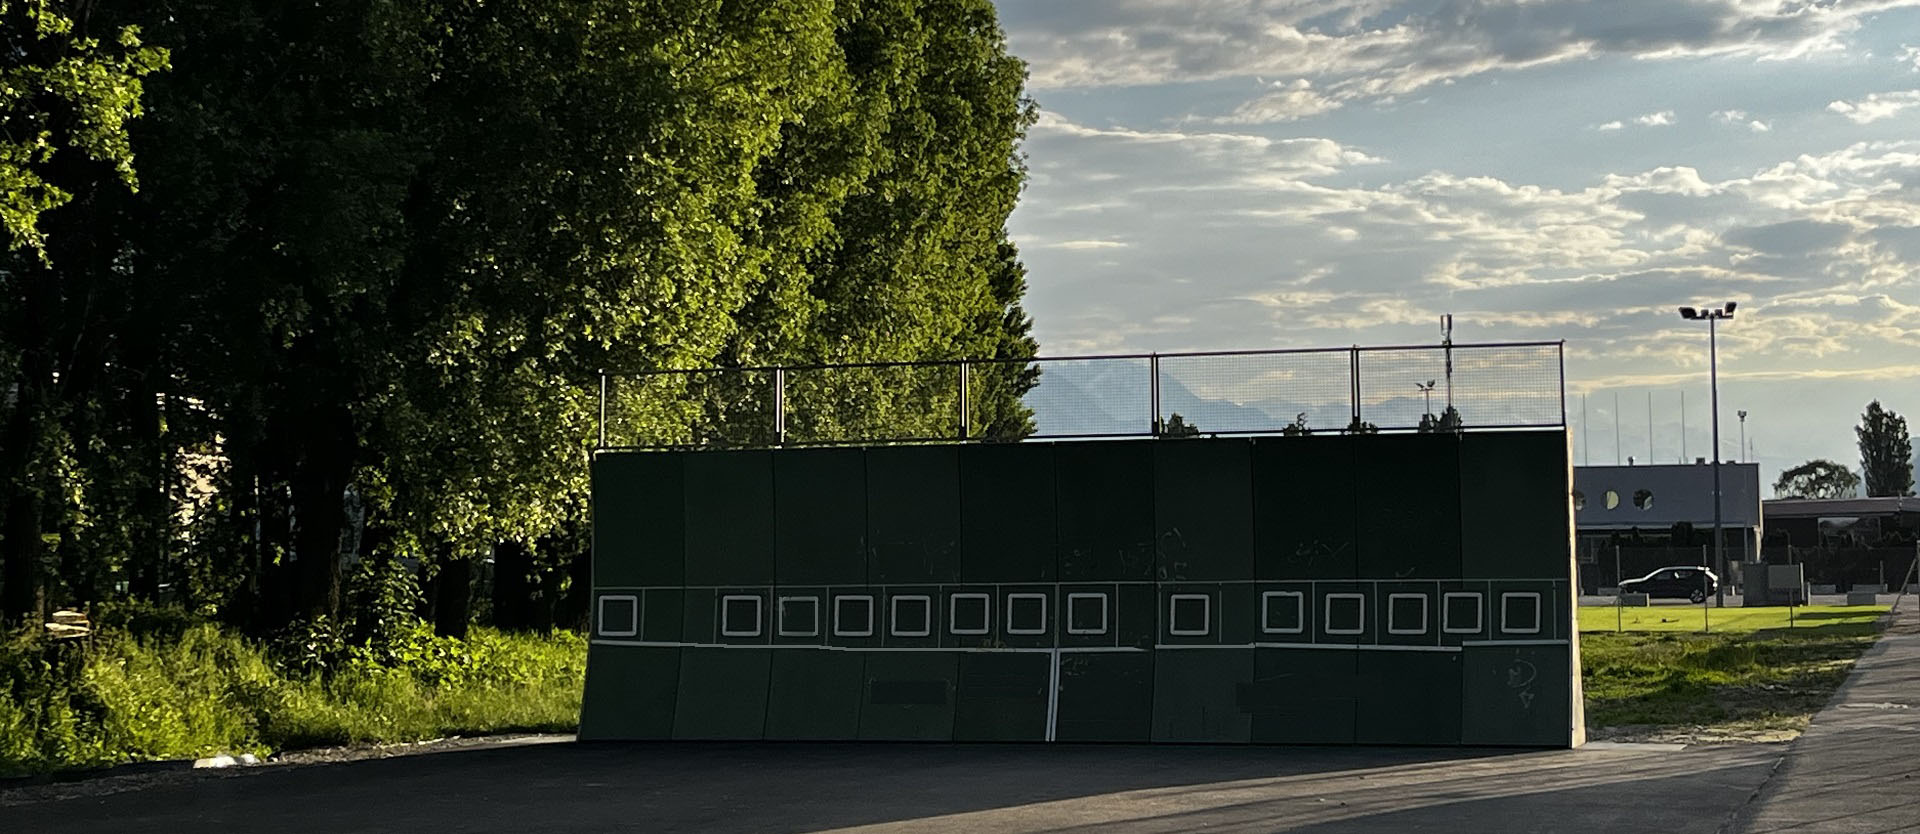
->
[[1152, 438, 1254, 580]]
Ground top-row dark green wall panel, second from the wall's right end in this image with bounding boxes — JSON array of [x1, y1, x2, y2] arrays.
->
[[1354, 432, 1461, 580]]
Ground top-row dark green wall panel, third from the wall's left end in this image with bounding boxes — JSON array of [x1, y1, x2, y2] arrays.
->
[[774, 448, 868, 584]]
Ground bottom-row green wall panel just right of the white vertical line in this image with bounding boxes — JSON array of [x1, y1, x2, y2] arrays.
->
[[1054, 651, 1158, 742]]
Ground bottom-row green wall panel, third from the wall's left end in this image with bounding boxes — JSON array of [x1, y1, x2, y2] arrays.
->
[[766, 650, 866, 742]]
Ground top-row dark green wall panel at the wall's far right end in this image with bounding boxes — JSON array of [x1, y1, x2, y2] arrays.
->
[[1459, 432, 1566, 578]]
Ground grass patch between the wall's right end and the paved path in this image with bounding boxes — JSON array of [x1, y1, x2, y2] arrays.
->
[[1580, 605, 1885, 742]]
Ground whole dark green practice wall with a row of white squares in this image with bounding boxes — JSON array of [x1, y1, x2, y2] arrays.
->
[[580, 430, 1584, 748]]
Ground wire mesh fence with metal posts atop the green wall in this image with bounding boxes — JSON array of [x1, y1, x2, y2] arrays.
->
[[599, 342, 1567, 448]]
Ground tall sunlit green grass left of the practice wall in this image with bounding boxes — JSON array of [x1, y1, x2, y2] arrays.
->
[[0, 623, 586, 774]]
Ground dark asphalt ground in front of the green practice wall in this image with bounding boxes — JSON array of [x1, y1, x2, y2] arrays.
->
[[0, 744, 1784, 834]]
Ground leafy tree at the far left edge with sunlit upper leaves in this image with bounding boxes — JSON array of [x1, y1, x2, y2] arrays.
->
[[0, 0, 167, 621]]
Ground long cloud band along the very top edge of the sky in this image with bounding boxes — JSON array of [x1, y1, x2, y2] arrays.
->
[[1002, 0, 1914, 100]]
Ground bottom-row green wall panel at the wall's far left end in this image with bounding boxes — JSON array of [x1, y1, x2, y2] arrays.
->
[[580, 644, 680, 742]]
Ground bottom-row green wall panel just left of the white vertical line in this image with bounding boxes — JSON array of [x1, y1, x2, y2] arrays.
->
[[954, 651, 1052, 742]]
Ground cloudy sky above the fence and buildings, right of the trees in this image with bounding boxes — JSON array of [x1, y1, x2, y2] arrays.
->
[[998, 0, 1920, 488]]
